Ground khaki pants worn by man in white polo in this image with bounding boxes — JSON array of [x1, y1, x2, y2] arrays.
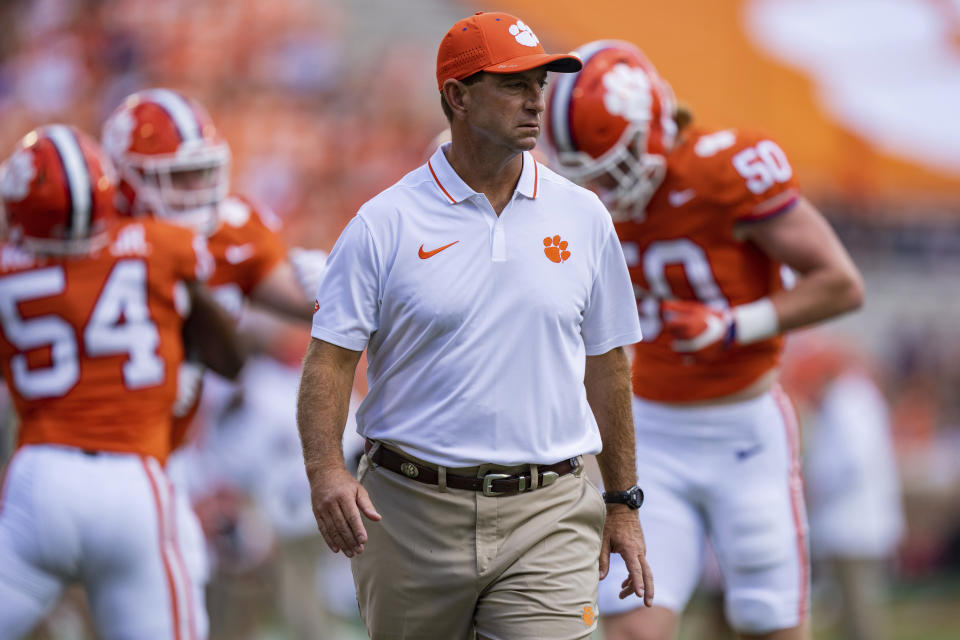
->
[[351, 448, 606, 640]]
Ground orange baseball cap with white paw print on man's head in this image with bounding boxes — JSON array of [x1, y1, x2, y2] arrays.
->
[[437, 11, 583, 89]]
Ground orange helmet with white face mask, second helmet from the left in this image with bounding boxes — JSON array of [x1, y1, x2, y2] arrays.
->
[[102, 89, 230, 232]]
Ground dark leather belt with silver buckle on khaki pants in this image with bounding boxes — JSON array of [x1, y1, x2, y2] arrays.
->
[[364, 440, 580, 496]]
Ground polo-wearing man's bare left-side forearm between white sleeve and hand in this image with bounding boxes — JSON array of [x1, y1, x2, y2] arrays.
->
[[297, 339, 360, 477]]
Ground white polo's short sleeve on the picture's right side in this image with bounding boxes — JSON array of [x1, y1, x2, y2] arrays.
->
[[580, 220, 641, 356]]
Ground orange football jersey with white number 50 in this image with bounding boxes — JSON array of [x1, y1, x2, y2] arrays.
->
[[615, 128, 799, 402]]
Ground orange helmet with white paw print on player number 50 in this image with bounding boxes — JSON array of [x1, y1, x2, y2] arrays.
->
[[546, 40, 677, 218]]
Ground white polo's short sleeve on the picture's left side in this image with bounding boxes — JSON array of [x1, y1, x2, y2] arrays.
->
[[310, 216, 381, 351]]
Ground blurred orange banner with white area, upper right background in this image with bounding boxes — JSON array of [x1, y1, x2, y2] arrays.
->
[[499, 0, 960, 209]]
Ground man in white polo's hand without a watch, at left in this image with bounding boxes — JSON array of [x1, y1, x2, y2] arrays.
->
[[310, 465, 381, 558]]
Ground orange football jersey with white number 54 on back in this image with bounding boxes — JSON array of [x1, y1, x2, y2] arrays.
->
[[0, 219, 212, 462]]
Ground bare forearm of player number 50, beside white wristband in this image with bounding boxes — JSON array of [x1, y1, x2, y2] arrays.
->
[[770, 265, 864, 331]]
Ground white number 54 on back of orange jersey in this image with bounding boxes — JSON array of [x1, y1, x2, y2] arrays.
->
[[0, 260, 164, 399]]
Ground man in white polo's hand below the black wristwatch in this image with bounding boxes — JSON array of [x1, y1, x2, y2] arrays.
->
[[600, 504, 653, 607]]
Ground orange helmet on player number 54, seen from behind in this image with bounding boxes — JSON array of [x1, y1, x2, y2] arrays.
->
[[0, 124, 116, 255]]
